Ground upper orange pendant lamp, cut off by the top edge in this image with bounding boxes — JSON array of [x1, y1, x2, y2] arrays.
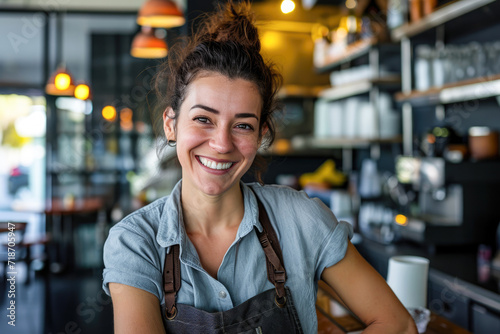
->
[[137, 0, 186, 28]]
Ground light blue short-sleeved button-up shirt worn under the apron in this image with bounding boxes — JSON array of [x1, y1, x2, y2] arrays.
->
[[103, 181, 352, 333]]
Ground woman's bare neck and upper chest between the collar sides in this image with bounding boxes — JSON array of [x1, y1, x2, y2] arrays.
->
[[181, 184, 245, 236]]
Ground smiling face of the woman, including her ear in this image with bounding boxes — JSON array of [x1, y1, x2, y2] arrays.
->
[[164, 73, 262, 195]]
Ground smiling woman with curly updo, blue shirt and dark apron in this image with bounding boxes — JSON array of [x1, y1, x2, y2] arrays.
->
[[99, 1, 416, 334]]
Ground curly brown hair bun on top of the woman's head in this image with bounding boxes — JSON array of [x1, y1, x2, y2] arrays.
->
[[201, 1, 260, 52]]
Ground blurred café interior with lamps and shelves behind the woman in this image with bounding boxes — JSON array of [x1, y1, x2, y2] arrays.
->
[[0, 0, 500, 333]]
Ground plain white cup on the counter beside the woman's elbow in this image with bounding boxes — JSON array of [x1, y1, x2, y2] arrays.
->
[[387, 256, 429, 308]]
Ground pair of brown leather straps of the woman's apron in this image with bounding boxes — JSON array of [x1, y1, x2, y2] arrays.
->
[[163, 188, 286, 320]]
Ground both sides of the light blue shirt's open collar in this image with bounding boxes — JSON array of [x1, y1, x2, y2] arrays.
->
[[156, 180, 262, 248]]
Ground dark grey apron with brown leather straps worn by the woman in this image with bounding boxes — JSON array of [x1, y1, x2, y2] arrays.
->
[[162, 192, 303, 334]]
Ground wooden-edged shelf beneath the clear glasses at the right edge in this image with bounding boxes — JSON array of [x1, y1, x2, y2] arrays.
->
[[395, 74, 500, 106]]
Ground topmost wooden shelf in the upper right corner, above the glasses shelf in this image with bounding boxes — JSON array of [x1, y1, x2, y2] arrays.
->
[[391, 0, 495, 42]]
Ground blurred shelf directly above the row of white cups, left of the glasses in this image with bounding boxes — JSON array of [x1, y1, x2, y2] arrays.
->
[[319, 75, 401, 101]]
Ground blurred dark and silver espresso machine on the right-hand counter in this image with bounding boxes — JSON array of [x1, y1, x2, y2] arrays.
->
[[396, 156, 500, 247]]
